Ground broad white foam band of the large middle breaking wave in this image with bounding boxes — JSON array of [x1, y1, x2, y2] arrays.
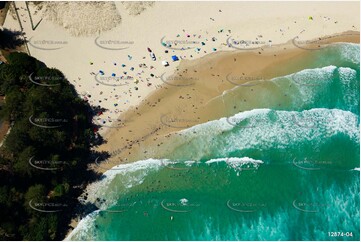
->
[[174, 108, 359, 160]]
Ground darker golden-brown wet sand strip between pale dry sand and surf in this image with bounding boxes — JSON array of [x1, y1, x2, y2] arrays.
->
[[93, 32, 360, 173]]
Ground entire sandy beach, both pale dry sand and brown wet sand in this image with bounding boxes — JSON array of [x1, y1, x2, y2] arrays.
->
[[3, 2, 360, 237]]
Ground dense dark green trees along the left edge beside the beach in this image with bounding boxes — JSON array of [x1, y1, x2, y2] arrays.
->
[[0, 52, 96, 240]]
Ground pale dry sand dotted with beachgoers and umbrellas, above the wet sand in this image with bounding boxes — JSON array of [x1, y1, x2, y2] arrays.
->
[[4, 2, 360, 135]]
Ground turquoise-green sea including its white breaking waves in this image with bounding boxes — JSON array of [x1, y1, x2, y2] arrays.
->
[[67, 44, 360, 240]]
